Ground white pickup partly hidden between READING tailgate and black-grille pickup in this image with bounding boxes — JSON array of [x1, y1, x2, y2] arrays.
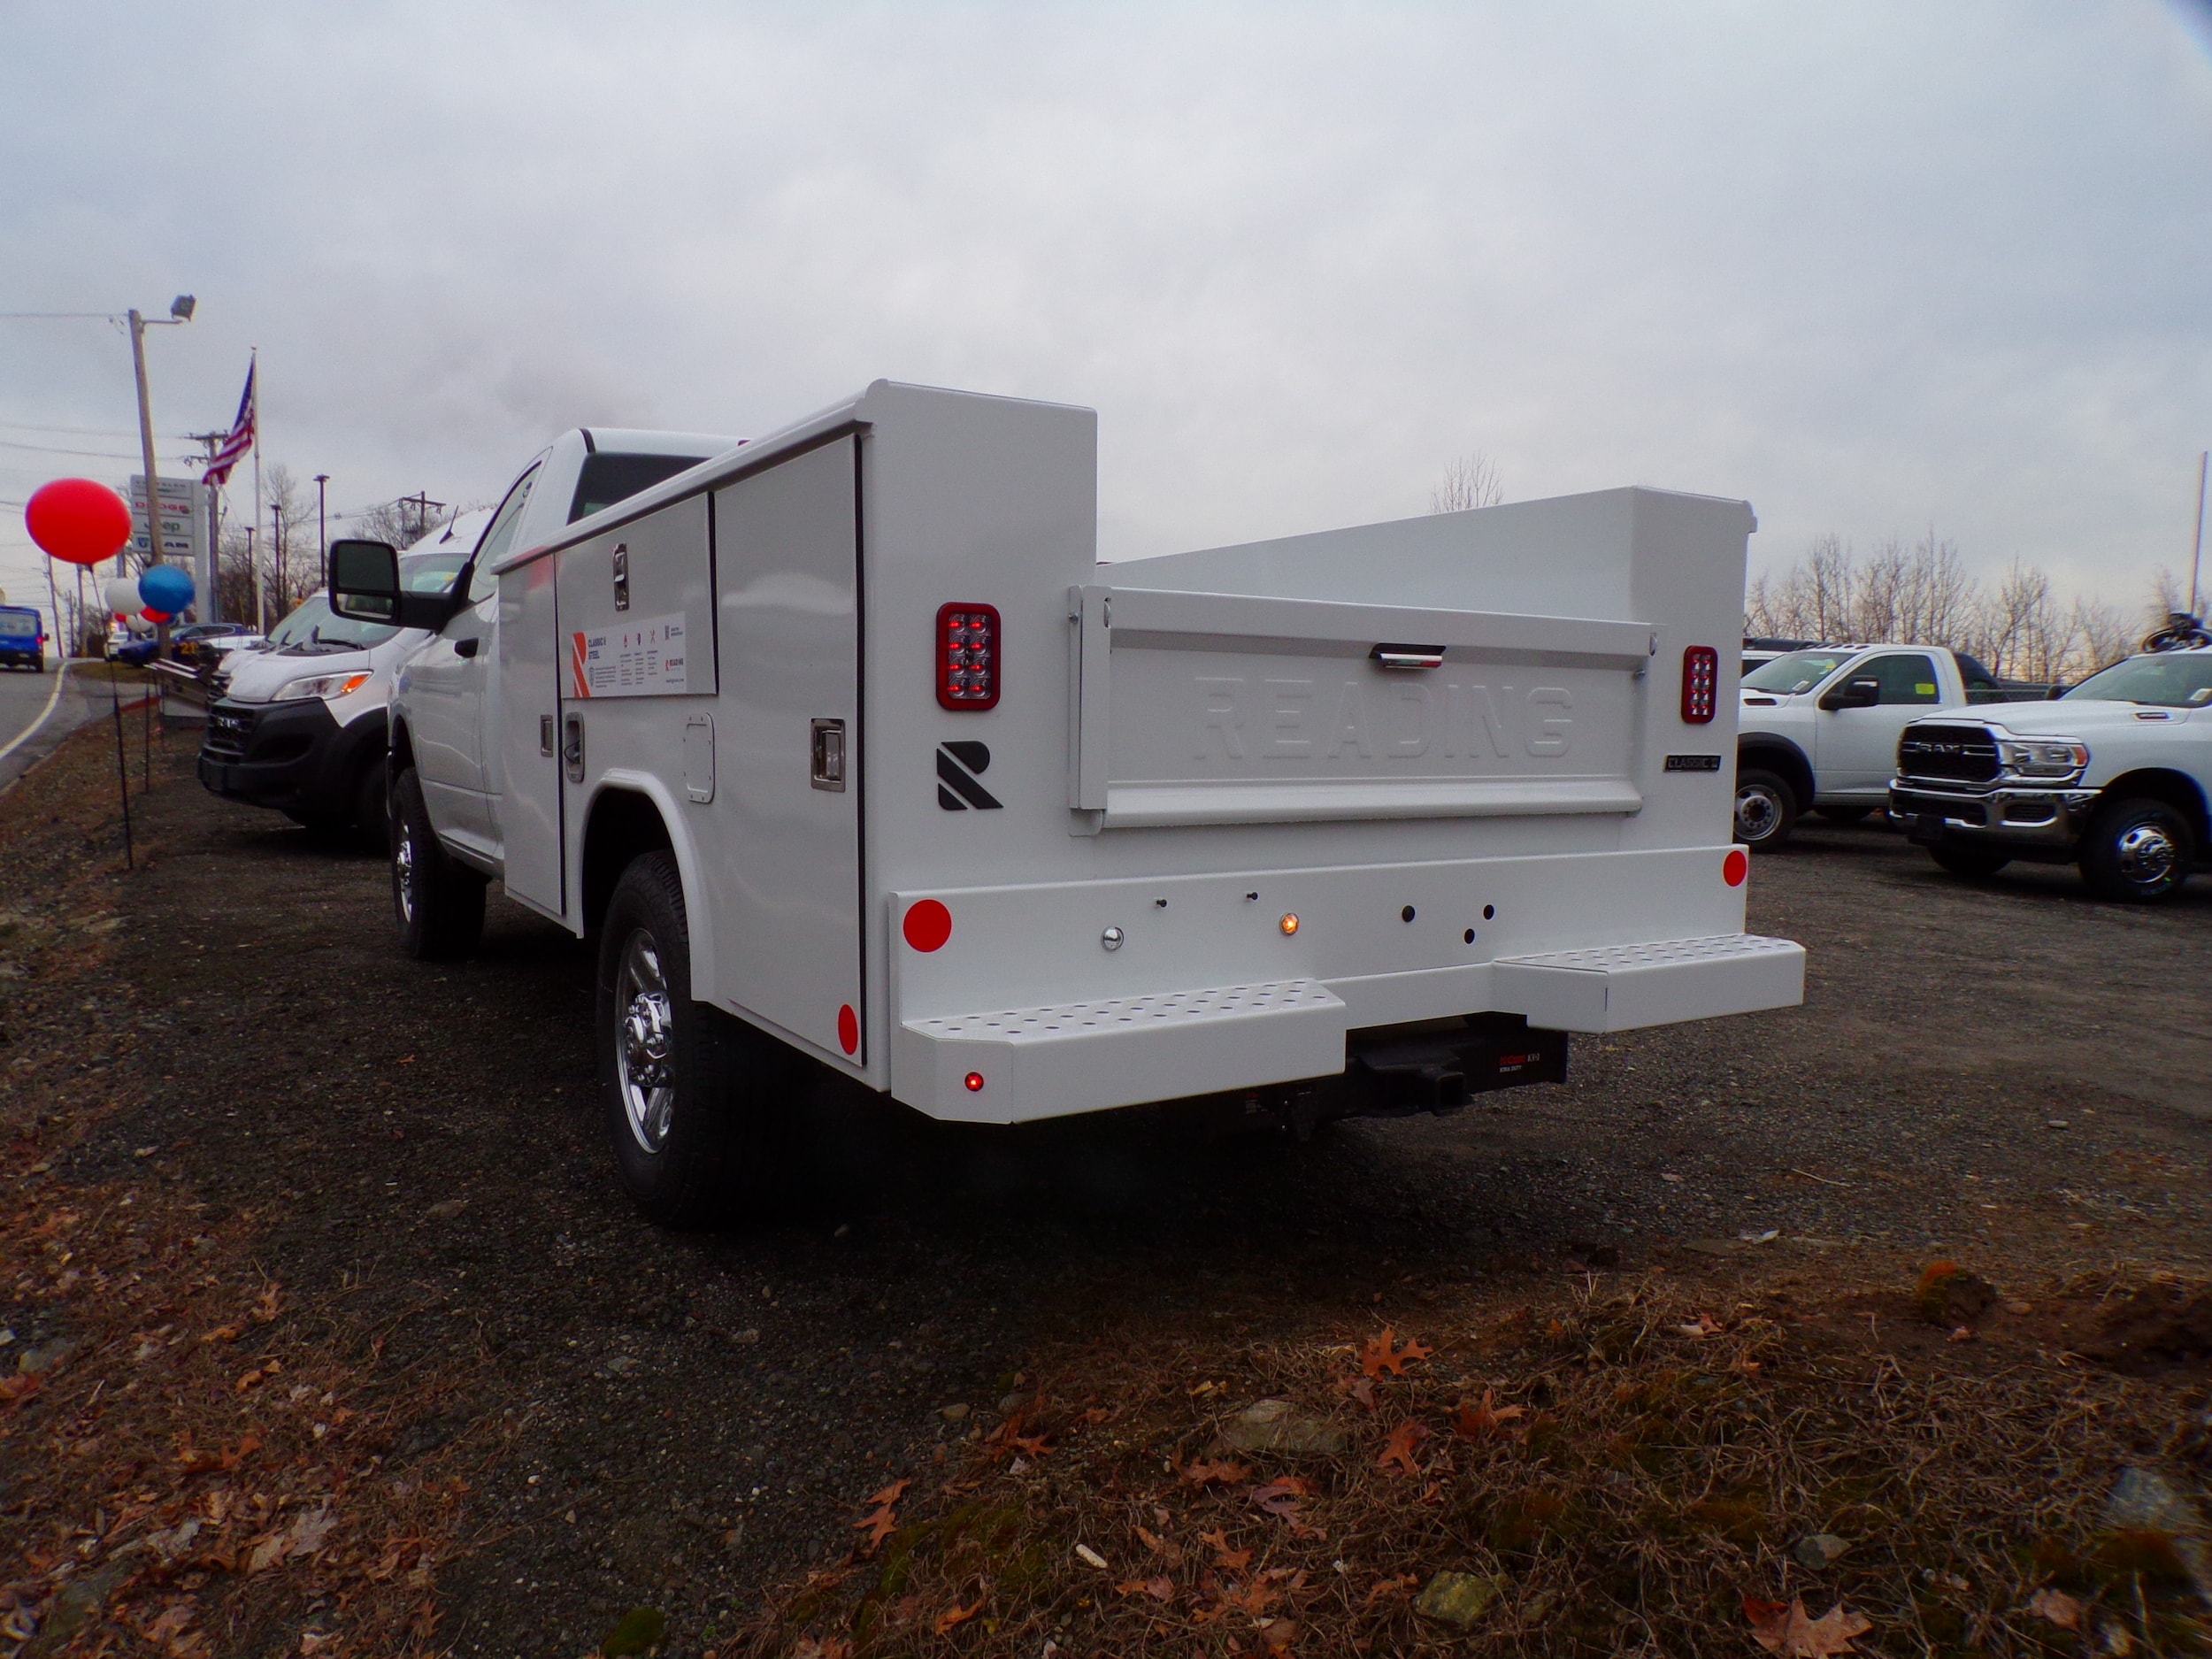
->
[[1737, 646, 2044, 849]]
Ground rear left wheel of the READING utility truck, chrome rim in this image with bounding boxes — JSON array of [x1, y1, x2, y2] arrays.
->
[[595, 852, 796, 1228]]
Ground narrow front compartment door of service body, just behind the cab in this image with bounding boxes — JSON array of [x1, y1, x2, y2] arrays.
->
[[500, 557, 569, 920]]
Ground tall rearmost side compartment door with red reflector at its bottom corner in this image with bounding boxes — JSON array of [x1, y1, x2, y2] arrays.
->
[[712, 438, 867, 1064]]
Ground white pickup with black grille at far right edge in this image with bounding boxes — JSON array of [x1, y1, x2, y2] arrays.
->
[[1889, 646, 2212, 902]]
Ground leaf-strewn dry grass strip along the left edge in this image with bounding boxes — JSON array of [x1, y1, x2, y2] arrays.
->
[[0, 728, 482, 1659]]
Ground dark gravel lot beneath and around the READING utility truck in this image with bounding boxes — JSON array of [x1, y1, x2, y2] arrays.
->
[[0, 733, 2212, 1655]]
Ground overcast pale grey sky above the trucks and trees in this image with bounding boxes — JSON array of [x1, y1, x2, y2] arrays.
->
[[0, 0, 2212, 628]]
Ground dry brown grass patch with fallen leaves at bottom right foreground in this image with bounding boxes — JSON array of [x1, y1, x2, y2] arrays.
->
[[730, 1279, 2208, 1657]]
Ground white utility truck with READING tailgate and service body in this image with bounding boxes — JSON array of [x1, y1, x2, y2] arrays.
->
[[332, 383, 1805, 1224]]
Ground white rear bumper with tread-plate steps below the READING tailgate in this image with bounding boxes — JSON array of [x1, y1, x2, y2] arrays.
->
[[885, 848, 1805, 1124]]
